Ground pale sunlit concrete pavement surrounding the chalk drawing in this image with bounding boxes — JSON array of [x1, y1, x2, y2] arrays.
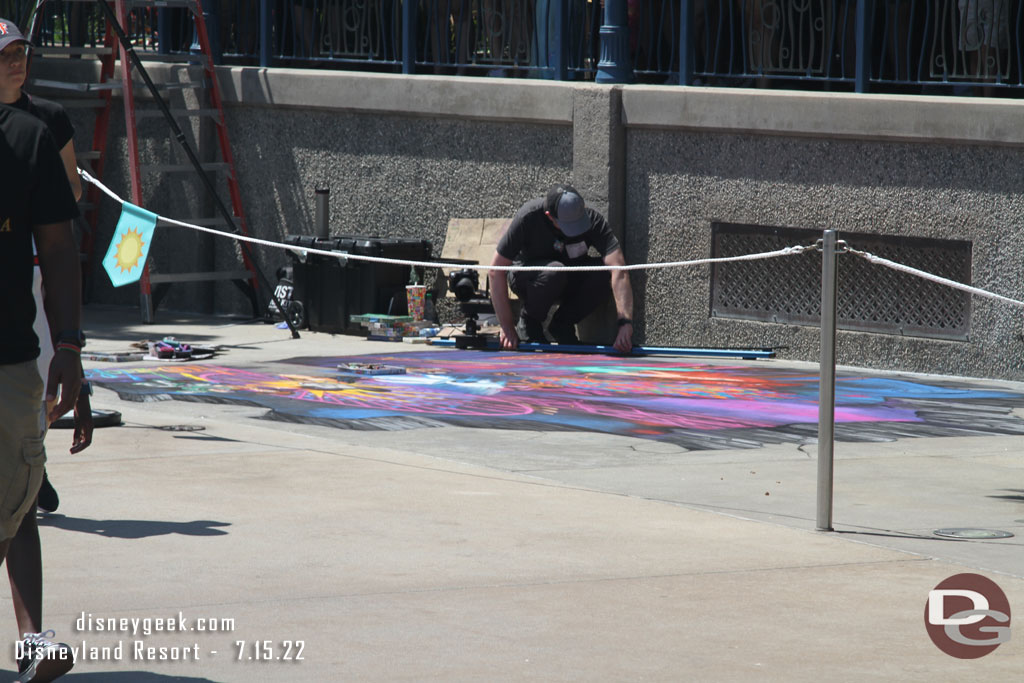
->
[[0, 308, 1024, 683]]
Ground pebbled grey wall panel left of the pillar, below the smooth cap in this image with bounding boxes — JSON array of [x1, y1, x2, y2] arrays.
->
[[228, 109, 571, 313]]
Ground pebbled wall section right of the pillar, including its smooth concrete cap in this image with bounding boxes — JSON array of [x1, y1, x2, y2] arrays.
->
[[623, 87, 1024, 379]]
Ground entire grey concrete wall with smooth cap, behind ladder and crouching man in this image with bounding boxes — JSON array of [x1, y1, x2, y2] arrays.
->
[[44, 63, 1024, 379]]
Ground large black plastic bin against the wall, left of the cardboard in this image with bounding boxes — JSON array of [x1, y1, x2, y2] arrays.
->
[[285, 234, 431, 335]]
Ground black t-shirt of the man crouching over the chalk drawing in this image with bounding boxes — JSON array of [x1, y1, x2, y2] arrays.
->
[[497, 197, 618, 265]]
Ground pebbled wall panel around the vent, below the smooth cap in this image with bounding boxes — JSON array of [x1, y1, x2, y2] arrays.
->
[[626, 129, 1024, 378]]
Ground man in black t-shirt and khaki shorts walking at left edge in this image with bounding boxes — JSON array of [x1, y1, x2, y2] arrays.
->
[[0, 100, 82, 682]]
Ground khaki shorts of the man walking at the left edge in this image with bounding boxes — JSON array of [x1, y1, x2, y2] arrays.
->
[[0, 360, 46, 541]]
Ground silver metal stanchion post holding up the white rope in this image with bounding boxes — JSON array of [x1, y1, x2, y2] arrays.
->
[[817, 230, 836, 531]]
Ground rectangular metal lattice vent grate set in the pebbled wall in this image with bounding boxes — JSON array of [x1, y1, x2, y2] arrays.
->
[[711, 223, 971, 340]]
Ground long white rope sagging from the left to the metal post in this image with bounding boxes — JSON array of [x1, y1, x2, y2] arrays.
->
[[78, 169, 817, 272]]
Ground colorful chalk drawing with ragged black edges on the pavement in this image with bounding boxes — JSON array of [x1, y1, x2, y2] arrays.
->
[[88, 350, 1024, 451]]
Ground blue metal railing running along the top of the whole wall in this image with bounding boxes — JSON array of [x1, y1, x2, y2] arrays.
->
[[19, 0, 1024, 96]]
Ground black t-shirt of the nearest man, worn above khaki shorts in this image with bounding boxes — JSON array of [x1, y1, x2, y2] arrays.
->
[[0, 104, 78, 365]]
